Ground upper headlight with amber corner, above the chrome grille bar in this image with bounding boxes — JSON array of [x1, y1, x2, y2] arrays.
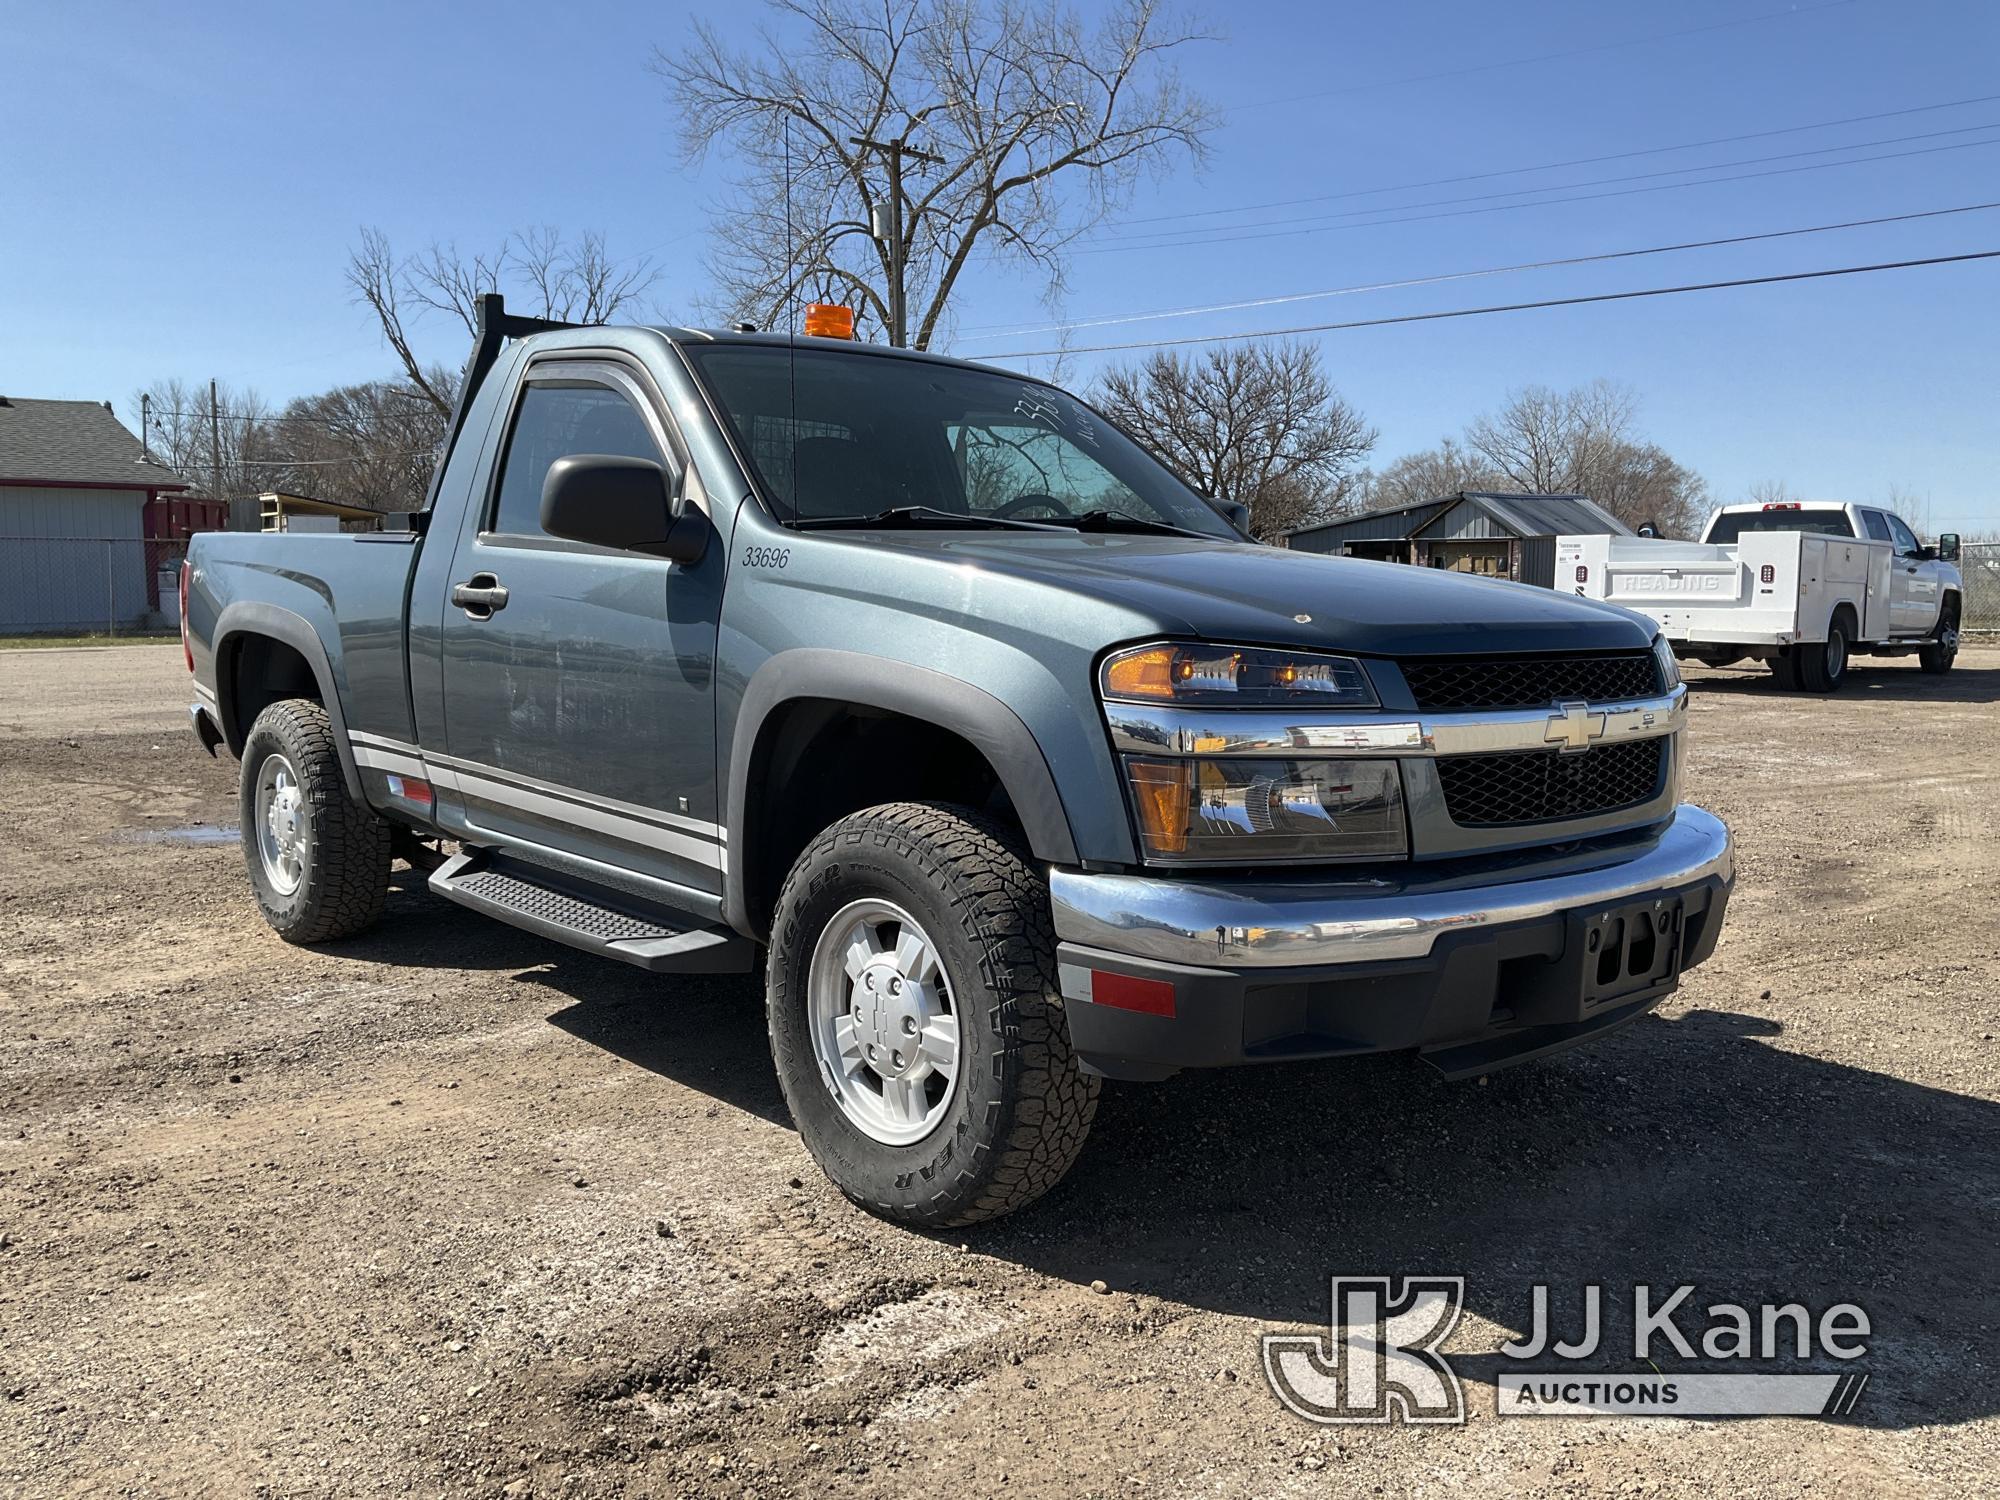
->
[[1098, 642, 1376, 708]]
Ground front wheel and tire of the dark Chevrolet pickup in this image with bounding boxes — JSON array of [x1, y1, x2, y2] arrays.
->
[[766, 802, 1098, 1228]]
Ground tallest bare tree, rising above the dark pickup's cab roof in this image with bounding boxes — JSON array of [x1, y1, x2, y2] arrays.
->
[[652, 0, 1214, 348]]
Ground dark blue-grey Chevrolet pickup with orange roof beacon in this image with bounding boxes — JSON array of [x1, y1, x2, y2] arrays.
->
[[182, 298, 1732, 1226]]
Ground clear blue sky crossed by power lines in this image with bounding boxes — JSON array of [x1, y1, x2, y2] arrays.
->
[[0, 0, 2000, 530]]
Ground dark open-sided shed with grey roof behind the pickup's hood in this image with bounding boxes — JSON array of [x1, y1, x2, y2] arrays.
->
[[1286, 490, 1632, 588]]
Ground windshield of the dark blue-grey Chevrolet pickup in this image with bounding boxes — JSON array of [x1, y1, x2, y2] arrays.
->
[[684, 344, 1240, 540]]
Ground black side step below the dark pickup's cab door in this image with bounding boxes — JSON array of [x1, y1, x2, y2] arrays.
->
[[430, 850, 756, 974]]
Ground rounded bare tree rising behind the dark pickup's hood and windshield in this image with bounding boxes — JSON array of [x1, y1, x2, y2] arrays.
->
[[1098, 342, 1376, 542]]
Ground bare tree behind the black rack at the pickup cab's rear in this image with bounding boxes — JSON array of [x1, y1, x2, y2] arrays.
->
[[348, 226, 660, 412]]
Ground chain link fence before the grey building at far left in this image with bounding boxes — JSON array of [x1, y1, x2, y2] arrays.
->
[[0, 536, 188, 636]]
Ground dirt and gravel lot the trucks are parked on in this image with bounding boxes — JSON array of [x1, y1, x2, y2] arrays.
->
[[0, 646, 2000, 1500]]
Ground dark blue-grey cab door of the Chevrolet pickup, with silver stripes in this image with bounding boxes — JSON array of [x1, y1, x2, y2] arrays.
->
[[434, 352, 724, 894]]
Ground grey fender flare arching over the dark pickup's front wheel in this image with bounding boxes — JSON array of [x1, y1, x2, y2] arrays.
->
[[722, 646, 1078, 930]]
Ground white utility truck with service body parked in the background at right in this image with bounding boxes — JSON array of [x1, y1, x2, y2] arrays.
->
[[1556, 500, 1964, 692]]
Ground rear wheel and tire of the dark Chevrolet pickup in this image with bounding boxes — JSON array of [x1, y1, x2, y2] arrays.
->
[[240, 698, 390, 944]]
